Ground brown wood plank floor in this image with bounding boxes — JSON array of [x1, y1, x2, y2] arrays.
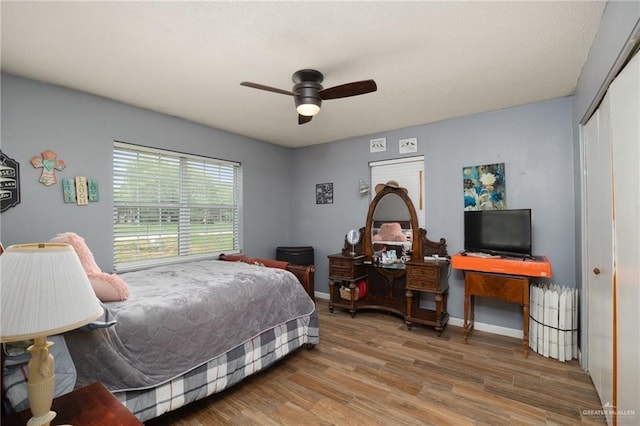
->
[[146, 299, 602, 426]]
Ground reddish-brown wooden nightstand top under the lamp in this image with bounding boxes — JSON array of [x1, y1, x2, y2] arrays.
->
[[2, 383, 142, 426]]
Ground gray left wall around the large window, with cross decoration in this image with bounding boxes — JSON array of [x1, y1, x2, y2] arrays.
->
[[0, 73, 292, 271]]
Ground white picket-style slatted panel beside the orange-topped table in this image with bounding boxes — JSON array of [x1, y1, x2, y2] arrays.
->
[[529, 284, 578, 362]]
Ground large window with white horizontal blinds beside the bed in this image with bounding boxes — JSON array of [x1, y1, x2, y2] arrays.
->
[[113, 142, 240, 271]]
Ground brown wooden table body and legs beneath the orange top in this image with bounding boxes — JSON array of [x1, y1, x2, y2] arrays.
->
[[464, 271, 529, 358]]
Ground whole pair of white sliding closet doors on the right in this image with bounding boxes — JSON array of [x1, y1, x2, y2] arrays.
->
[[583, 50, 640, 425]]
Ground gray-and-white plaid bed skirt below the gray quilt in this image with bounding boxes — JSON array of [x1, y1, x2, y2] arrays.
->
[[113, 311, 319, 422]]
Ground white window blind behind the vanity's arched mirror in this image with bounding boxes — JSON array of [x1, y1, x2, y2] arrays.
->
[[369, 155, 425, 228]]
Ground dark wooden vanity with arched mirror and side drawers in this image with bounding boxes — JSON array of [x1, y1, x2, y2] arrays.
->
[[328, 181, 449, 335]]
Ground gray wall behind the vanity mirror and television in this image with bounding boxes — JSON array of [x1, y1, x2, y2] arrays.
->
[[292, 98, 575, 329]]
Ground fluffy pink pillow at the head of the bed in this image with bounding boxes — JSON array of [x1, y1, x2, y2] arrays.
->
[[49, 232, 129, 302]]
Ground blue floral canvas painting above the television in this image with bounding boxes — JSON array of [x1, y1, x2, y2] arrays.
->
[[462, 163, 507, 210]]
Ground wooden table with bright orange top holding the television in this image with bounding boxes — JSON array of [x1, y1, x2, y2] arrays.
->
[[451, 253, 551, 357]]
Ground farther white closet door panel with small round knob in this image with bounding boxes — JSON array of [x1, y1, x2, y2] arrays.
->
[[584, 98, 614, 414]]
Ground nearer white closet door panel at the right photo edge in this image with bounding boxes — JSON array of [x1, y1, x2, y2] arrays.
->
[[609, 50, 640, 425]]
